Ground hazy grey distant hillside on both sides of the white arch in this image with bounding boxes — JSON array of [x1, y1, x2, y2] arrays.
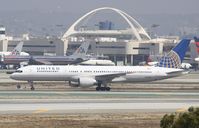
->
[[0, 11, 199, 36]]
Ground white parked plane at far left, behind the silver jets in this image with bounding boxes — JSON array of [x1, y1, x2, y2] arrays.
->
[[0, 42, 29, 56]]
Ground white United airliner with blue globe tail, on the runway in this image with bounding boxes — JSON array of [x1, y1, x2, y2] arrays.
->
[[10, 39, 190, 91]]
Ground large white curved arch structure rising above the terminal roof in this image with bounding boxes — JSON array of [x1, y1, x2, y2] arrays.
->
[[63, 7, 151, 41]]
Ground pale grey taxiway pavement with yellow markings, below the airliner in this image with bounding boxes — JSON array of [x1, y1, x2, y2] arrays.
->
[[0, 91, 199, 114]]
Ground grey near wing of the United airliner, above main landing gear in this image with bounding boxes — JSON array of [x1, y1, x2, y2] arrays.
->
[[95, 73, 127, 81]]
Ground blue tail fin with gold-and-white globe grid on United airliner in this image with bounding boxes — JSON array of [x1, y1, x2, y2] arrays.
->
[[158, 39, 191, 68]]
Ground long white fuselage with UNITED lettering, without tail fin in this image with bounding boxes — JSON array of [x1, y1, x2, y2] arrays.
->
[[11, 65, 183, 82]]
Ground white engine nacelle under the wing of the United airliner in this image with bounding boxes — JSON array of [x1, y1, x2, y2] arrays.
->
[[69, 77, 97, 88]]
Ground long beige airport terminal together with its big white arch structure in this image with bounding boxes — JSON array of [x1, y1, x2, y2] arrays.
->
[[0, 7, 183, 65]]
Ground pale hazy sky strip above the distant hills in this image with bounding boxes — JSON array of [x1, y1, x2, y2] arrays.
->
[[0, 0, 199, 14]]
